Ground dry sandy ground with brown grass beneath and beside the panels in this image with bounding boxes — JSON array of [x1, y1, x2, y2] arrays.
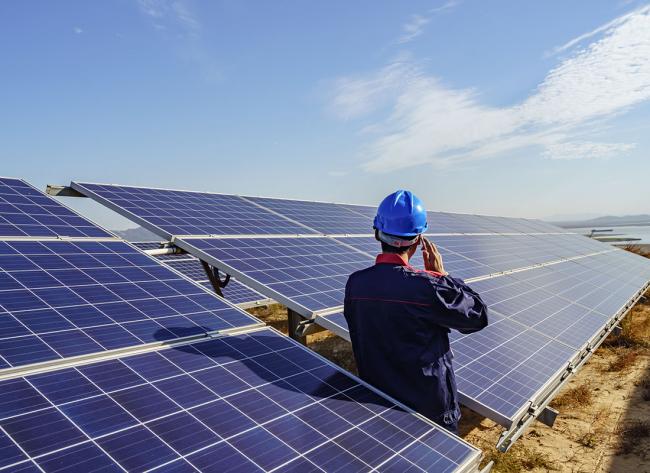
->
[[250, 268, 650, 473]]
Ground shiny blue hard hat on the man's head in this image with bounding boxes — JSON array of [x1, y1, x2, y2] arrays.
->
[[374, 190, 429, 237]]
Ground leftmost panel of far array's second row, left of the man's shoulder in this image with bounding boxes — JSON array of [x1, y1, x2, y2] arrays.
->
[[176, 237, 373, 315]]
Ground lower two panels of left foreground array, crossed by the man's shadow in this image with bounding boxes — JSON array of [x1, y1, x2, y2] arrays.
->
[[0, 178, 480, 472]]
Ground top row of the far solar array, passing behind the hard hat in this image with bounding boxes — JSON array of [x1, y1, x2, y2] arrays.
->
[[72, 182, 566, 239]]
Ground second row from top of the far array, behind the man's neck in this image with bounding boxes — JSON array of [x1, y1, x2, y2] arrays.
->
[[177, 230, 610, 315]]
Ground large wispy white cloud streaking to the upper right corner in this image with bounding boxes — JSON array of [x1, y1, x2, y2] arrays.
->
[[332, 8, 650, 172]]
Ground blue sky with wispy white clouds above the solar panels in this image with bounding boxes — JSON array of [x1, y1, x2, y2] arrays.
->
[[0, 0, 650, 228]]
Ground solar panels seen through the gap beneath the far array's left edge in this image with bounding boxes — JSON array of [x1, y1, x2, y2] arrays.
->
[[132, 242, 270, 307]]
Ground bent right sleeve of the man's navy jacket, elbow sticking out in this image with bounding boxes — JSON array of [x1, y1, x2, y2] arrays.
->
[[431, 276, 488, 333]]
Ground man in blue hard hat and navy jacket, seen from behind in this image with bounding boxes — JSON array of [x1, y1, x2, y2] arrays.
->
[[344, 190, 488, 433]]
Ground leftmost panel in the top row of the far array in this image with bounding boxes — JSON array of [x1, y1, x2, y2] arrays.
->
[[72, 182, 314, 240]]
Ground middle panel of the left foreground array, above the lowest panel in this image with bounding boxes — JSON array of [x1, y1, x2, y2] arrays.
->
[[0, 240, 259, 366]]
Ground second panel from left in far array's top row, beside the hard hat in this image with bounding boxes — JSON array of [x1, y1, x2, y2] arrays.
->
[[246, 197, 373, 235]]
